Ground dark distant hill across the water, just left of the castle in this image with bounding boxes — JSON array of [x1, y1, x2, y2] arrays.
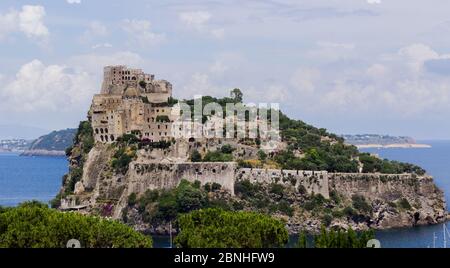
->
[[23, 128, 77, 155]]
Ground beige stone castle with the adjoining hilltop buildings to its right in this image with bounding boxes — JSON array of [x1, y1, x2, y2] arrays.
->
[[88, 65, 278, 147]]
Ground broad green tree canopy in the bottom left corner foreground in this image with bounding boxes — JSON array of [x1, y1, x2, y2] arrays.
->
[[0, 202, 152, 248]]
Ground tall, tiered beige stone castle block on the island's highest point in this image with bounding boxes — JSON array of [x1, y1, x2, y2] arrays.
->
[[89, 66, 173, 143]]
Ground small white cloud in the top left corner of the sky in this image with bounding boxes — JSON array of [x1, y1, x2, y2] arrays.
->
[[0, 5, 50, 40]]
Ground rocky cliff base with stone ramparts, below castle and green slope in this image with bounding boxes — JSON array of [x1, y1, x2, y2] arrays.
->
[[57, 134, 447, 233]]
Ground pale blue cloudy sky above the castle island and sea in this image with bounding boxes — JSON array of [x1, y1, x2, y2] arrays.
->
[[0, 0, 450, 139]]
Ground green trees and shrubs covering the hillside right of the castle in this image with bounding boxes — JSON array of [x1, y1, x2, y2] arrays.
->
[[179, 89, 425, 175]]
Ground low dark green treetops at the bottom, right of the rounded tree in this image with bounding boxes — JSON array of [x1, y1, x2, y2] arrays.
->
[[297, 227, 375, 248]]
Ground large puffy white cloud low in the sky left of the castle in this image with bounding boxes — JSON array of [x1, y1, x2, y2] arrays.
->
[[0, 60, 96, 113]]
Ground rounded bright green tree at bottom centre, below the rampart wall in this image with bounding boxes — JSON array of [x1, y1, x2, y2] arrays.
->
[[175, 209, 288, 248]]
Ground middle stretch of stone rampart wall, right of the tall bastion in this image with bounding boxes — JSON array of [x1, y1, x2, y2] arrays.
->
[[236, 168, 330, 198]]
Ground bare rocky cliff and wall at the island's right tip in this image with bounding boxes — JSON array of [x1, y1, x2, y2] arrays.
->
[[330, 173, 447, 229]]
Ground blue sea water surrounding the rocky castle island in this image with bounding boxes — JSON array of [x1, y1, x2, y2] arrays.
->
[[0, 141, 450, 248]]
